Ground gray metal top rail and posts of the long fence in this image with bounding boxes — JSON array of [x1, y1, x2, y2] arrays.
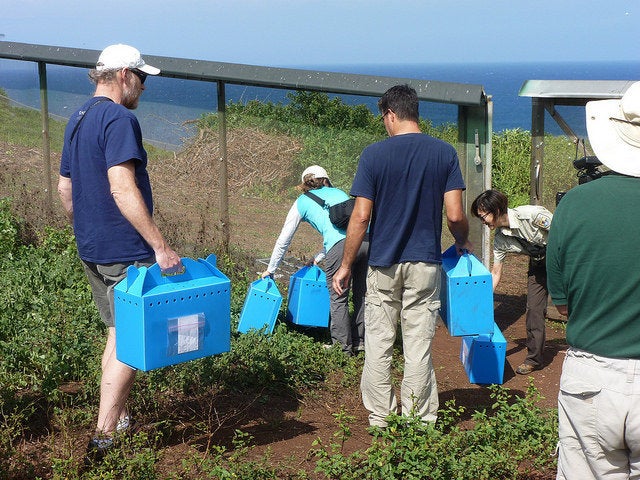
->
[[0, 42, 493, 258]]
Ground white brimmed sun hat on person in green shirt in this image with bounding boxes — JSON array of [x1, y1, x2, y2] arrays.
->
[[586, 82, 640, 177]]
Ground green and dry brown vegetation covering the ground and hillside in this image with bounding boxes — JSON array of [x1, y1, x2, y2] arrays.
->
[[0, 92, 575, 480]]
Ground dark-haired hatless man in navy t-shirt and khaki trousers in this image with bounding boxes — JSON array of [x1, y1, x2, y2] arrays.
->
[[333, 85, 472, 427]]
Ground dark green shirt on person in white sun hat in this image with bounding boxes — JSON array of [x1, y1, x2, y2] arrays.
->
[[547, 174, 640, 359]]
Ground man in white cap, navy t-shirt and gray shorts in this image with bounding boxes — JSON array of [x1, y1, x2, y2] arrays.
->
[[58, 44, 182, 459]]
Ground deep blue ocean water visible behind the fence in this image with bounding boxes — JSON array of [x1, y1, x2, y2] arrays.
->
[[0, 59, 640, 148]]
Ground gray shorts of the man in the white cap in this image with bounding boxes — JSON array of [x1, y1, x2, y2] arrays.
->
[[82, 257, 155, 327]]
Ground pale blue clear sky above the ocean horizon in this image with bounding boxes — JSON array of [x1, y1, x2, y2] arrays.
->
[[0, 0, 640, 68]]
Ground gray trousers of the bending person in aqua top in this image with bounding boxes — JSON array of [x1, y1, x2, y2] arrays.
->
[[324, 237, 369, 355]]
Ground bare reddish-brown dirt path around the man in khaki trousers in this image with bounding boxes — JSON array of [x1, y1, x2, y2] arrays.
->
[[244, 257, 566, 468]]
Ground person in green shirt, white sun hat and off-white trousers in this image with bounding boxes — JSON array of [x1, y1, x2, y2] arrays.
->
[[547, 82, 640, 480]]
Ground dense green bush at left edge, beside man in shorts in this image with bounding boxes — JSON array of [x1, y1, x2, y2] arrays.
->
[[0, 216, 102, 396]]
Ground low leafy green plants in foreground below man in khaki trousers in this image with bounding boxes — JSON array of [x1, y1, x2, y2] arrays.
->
[[314, 385, 557, 480]]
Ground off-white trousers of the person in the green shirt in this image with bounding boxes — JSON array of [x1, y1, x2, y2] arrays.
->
[[556, 348, 640, 480]]
